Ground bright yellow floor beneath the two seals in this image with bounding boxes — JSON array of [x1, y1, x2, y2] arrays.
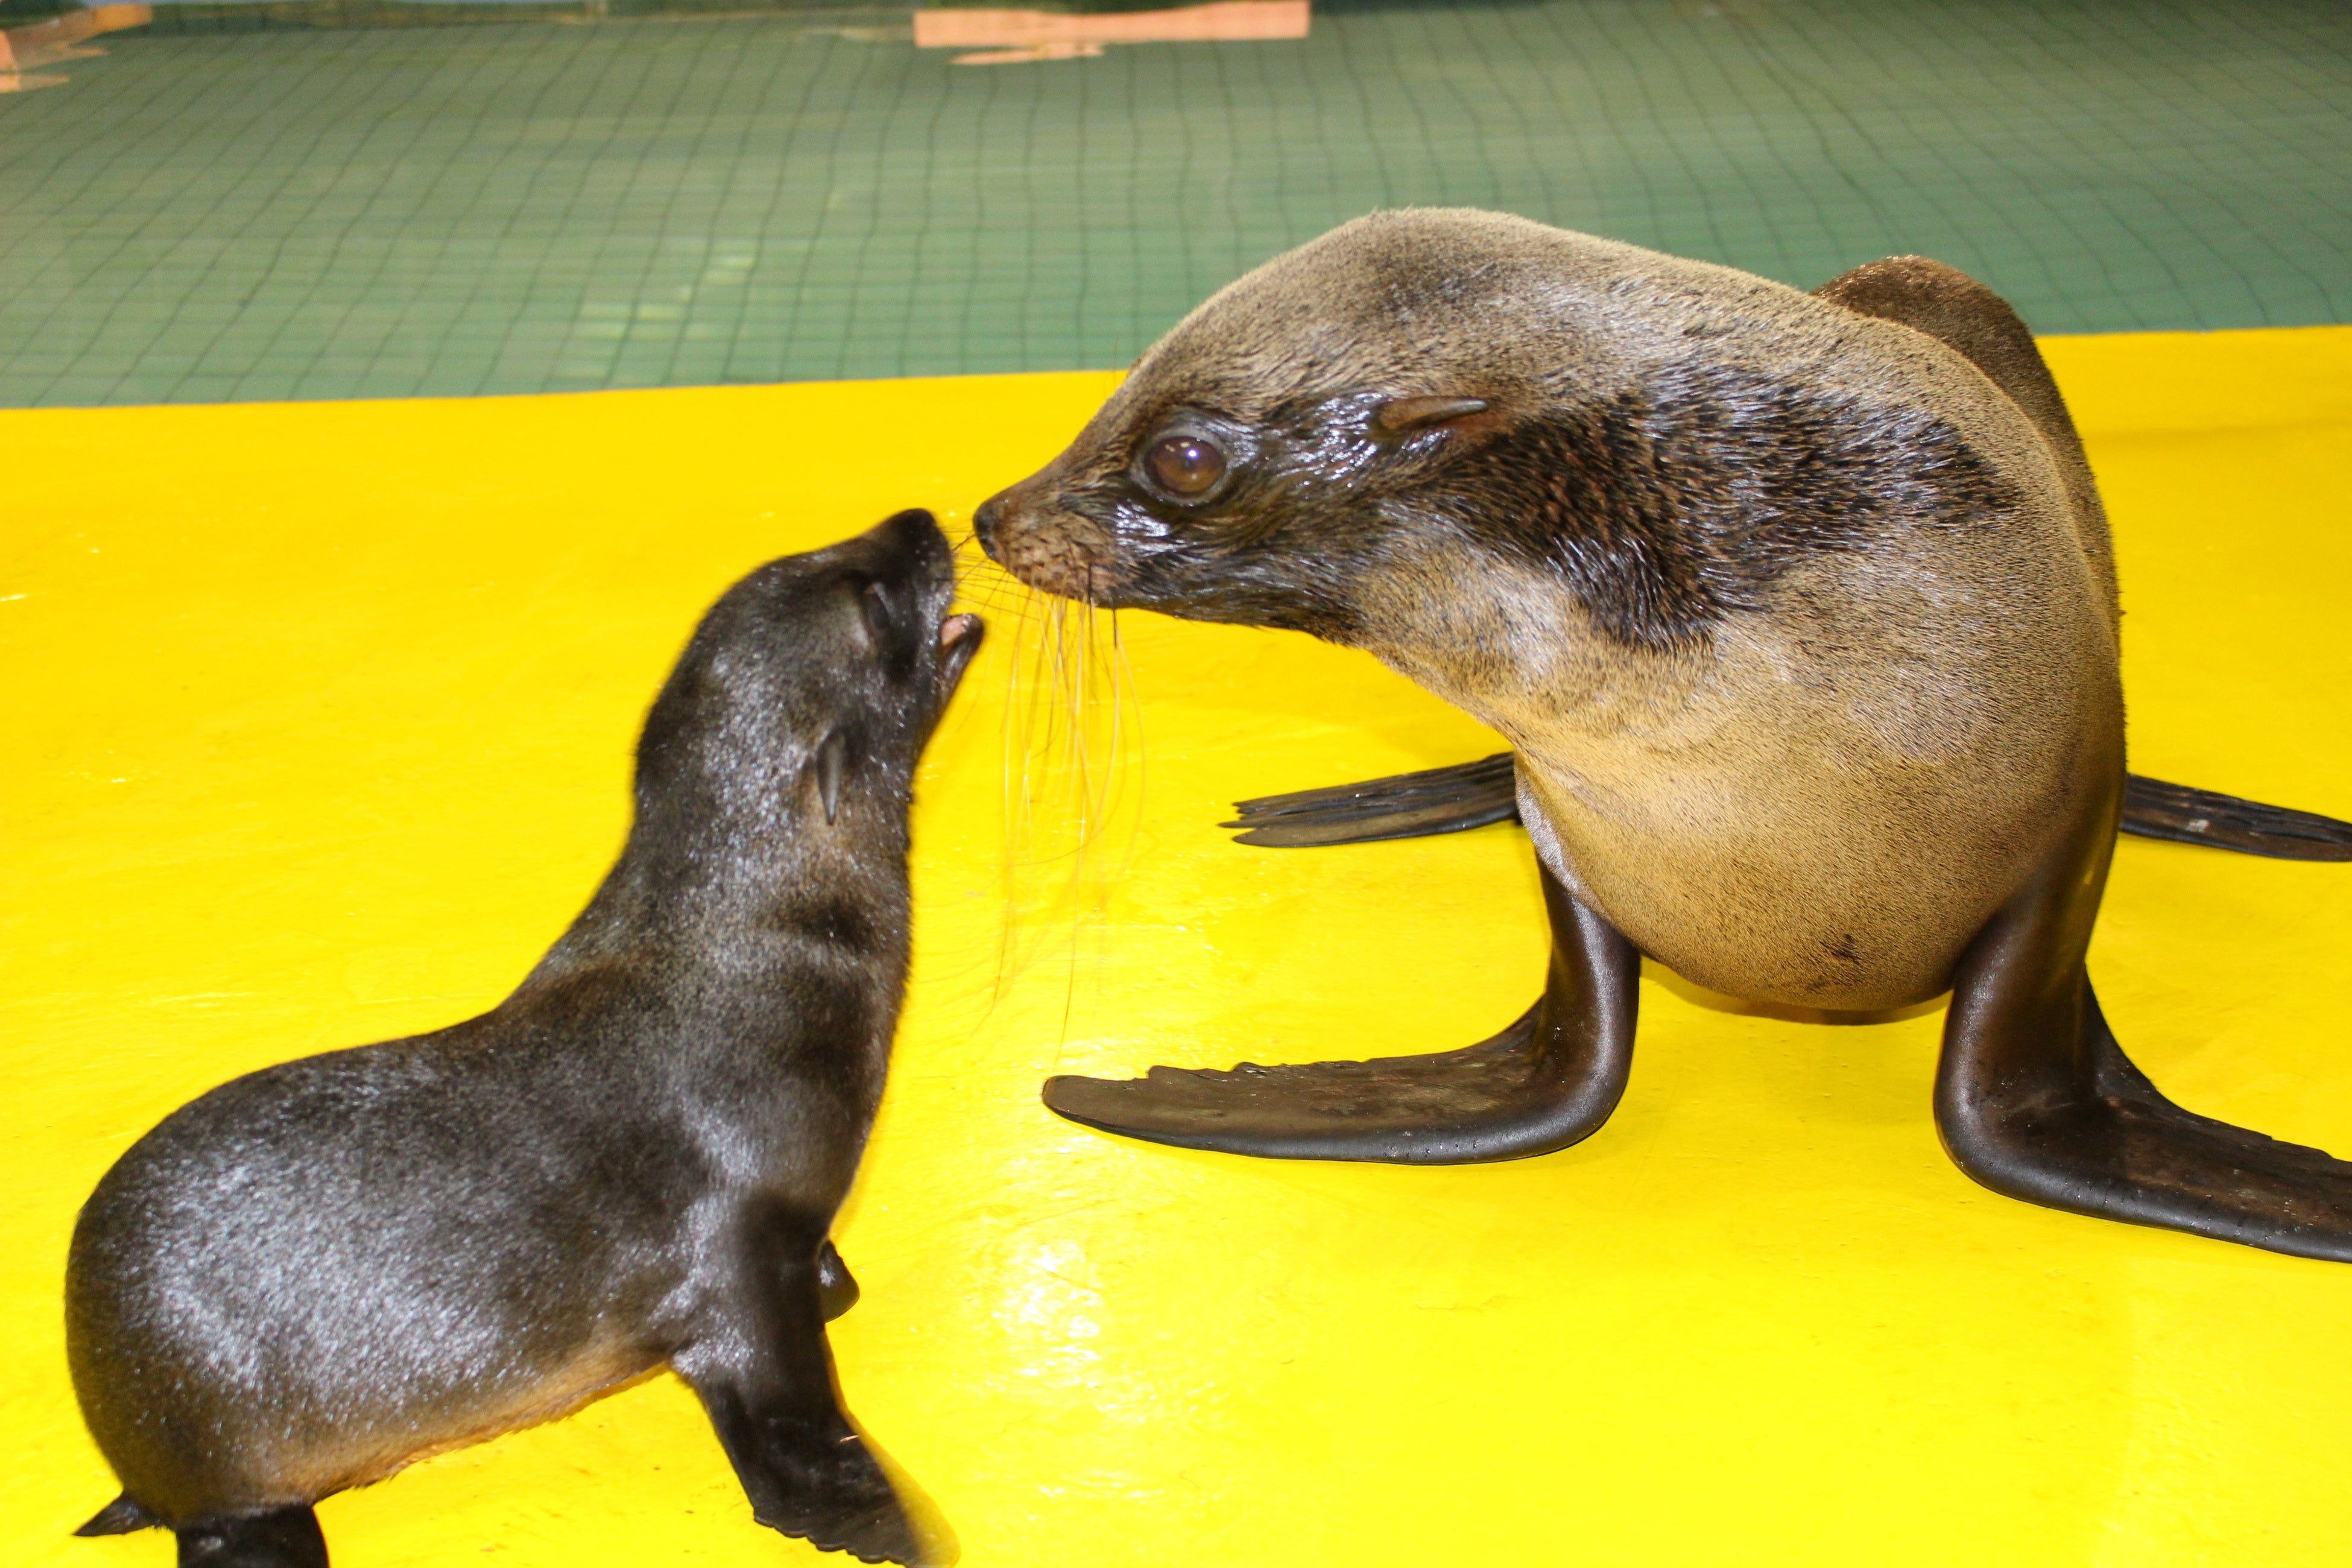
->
[[0, 329, 2352, 1568]]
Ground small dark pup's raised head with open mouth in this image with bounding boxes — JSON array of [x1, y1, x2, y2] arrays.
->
[[637, 510, 983, 853]]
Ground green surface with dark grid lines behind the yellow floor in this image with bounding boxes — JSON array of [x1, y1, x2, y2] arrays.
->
[[0, 0, 2352, 406]]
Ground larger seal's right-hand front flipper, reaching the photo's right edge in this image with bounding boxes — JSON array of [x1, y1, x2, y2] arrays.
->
[[1936, 780, 2352, 1262]]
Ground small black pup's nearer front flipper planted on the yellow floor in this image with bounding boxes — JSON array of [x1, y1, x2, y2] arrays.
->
[[671, 1215, 955, 1568]]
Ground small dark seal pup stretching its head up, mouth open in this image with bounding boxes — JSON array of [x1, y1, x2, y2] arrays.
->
[[66, 513, 981, 1568]]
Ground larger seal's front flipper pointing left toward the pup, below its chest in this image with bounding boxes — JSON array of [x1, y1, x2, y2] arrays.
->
[[1045, 872, 1642, 1166]]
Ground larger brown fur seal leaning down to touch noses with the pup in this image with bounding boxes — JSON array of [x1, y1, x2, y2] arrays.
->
[[976, 212, 2352, 1260]]
